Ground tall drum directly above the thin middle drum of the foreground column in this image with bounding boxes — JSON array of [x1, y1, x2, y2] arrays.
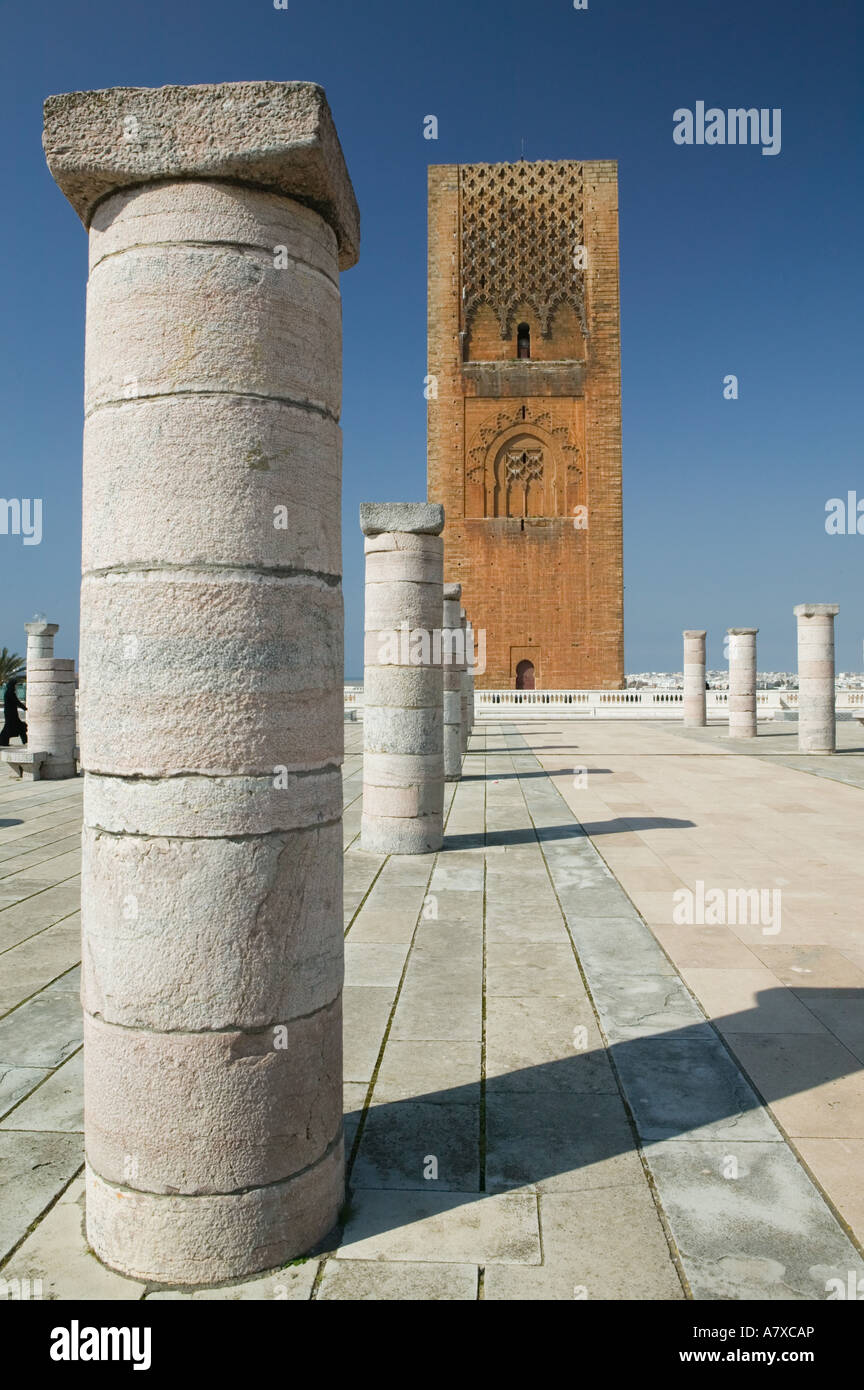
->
[[81, 571, 343, 777]]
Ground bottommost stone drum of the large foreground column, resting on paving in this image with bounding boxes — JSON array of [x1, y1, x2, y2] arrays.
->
[[86, 1136, 344, 1284]]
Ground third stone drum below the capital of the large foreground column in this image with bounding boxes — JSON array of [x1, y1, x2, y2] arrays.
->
[[82, 396, 342, 577]]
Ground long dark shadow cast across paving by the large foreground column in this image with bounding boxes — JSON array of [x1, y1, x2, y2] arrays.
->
[[346, 988, 864, 1238]]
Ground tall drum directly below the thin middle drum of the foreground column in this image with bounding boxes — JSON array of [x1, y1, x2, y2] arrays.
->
[[82, 823, 343, 1031]]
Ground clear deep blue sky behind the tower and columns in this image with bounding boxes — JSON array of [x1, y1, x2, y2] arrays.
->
[[0, 0, 864, 674]]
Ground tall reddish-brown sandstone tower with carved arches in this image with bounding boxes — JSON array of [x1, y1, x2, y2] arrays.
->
[[426, 160, 624, 689]]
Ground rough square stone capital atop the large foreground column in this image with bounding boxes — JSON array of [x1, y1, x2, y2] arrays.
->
[[42, 82, 360, 270]]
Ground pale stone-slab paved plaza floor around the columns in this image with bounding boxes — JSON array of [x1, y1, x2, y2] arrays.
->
[[0, 720, 864, 1300]]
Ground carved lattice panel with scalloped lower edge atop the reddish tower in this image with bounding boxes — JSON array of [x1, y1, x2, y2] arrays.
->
[[460, 160, 588, 338]]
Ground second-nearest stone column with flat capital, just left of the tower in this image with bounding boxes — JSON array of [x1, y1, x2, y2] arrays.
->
[[360, 502, 445, 855]]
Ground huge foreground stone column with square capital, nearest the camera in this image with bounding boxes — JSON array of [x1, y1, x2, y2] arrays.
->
[[44, 82, 358, 1283]]
